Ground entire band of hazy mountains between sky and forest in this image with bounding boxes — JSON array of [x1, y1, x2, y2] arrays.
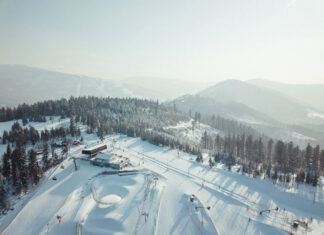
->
[[0, 65, 324, 144]]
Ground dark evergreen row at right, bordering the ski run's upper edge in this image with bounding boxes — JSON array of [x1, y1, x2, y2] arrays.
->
[[201, 132, 324, 186]]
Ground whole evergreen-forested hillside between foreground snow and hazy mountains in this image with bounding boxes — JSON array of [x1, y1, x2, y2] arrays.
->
[[0, 97, 324, 212]]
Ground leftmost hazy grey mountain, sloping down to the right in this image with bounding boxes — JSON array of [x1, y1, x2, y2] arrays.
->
[[0, 65, 137, 106]]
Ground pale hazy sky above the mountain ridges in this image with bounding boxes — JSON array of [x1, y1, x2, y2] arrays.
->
[[0, 0, 324, 83]]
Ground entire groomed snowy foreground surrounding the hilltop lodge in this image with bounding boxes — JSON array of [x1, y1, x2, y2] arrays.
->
[[0, 119, 324, 235]]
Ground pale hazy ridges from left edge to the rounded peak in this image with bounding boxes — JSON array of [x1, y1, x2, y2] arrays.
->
[[0, 65, 207, 107]]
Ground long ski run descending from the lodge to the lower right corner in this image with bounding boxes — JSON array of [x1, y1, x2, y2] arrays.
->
[[109, 137, 324, 234]]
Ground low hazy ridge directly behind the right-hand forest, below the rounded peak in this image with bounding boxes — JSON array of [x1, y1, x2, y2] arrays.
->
[[171, 95, 324, 146]]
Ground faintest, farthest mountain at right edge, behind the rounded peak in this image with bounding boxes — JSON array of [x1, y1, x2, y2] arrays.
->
[[248, 79, 324, 112]]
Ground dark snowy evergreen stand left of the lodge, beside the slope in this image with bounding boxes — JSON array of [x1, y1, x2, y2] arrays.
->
[[0, 122, 74, 212]]
